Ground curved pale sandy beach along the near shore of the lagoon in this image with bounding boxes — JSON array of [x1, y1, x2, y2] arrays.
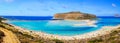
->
[[7, 24, 120, 40]]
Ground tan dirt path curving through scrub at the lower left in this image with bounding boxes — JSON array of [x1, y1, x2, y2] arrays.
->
[[0, 28, 20, 43]]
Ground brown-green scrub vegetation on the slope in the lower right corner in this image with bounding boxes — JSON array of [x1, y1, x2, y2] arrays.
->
[[89, 28, 120, 43]]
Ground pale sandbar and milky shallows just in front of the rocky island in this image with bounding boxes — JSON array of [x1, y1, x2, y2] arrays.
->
[[47, 20, 97, 27]]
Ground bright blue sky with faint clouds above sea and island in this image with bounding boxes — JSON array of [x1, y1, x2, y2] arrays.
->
[[0, 0, 120, 16]]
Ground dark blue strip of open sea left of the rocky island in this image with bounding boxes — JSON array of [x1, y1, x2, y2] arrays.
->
[[3, 16, 52, 20]]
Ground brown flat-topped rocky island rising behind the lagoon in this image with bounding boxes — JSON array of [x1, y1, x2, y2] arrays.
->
[[54, 12, 96, 20]]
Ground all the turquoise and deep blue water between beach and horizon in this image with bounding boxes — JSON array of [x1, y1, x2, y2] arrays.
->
[[3, 16, 120, 36]]
